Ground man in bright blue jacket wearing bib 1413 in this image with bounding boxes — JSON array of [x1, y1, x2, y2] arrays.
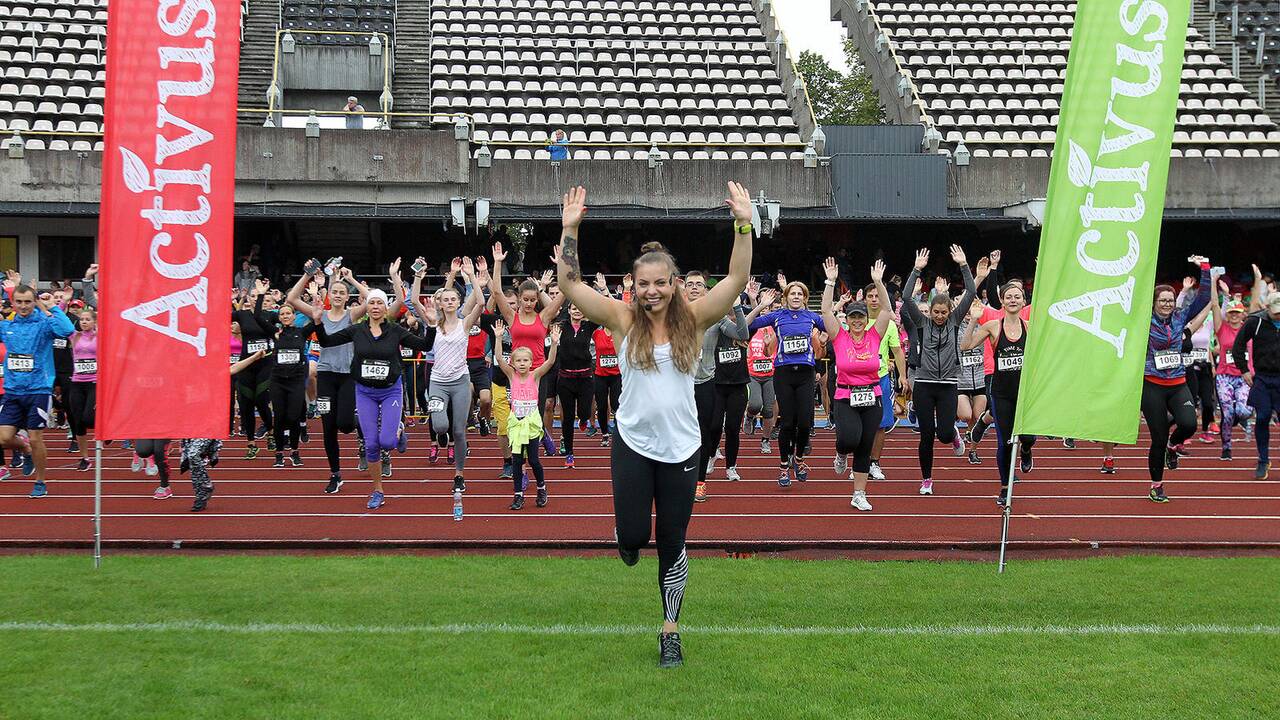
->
[[0, 284, 76, 497]]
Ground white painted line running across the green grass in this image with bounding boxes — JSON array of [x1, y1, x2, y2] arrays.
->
[[0, 620, 1280, 638]]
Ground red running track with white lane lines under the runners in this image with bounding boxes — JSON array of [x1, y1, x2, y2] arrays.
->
[[0, 417, 1280, 550]]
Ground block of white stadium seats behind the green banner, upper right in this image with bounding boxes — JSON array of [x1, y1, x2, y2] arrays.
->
[[864, 1, 1280, 158]]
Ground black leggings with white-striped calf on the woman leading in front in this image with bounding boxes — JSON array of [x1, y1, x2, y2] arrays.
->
[[611, 433, 699, 623]]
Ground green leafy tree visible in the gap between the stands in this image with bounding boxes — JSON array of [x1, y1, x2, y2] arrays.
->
[[796, 40, 884, 126]]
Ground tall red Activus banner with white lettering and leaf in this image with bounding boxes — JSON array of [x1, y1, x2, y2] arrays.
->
[[97, 0, 239, 439]]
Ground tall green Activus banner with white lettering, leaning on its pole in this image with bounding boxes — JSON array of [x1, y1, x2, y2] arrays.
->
[[1015, 0, 1190, 443]]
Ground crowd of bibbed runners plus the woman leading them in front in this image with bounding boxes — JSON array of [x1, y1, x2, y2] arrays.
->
[[0, 183, 1280, 664]]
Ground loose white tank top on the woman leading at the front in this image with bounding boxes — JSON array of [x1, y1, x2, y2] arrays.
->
[[616, 338, 701, 462]]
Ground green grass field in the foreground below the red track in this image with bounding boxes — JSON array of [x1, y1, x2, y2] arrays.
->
[[0, 555, 1280, 720]]
